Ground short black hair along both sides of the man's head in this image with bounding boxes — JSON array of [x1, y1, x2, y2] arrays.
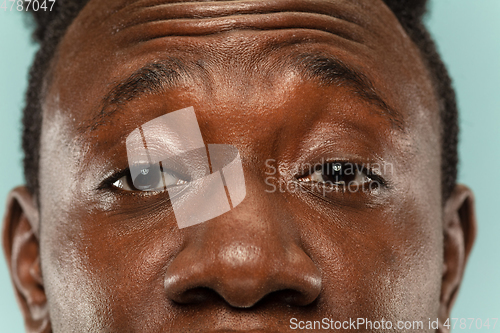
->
[[22, 0, 458, 202]]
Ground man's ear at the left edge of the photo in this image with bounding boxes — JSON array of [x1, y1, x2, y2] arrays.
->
[[2, 187, 51, 332]]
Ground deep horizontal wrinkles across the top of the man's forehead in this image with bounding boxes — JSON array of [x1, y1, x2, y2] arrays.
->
[[100, 0, 371, 45]]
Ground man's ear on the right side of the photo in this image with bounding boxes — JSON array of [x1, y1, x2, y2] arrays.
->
[[439, 185, 477, 332]]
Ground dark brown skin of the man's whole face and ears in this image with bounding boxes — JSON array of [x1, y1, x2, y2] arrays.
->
[[3, 0, 476, 332]]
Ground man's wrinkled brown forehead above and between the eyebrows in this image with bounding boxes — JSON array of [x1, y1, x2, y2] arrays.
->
[[45, 0, 438, 160]]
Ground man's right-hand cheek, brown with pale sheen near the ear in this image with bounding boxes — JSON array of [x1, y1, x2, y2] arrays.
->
[[294, 191, 442, 322]]
